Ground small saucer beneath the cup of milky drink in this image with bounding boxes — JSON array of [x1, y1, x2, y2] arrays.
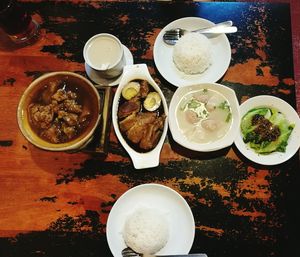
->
[[84, 45, 133, 87]]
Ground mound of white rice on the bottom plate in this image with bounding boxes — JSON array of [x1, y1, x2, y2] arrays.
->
[[123, 208, 169, 254]]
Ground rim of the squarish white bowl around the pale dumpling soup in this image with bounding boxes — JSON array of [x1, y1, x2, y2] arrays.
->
[[169, 83, 240, 152]]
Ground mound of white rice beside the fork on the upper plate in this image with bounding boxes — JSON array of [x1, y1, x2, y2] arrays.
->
[[173, 33, 212, 74]]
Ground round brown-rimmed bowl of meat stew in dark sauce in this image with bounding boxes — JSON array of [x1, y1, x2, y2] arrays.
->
[[17, 71, 100, 151]]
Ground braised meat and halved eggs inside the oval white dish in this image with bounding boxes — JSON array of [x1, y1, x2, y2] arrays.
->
[[117, 79, 166, 152]]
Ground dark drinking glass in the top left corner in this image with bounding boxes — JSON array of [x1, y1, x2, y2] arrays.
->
[[0, 0, 39, 43]]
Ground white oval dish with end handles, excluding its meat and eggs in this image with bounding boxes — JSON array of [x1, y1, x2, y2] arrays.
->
[[112, 64, 168, 169]]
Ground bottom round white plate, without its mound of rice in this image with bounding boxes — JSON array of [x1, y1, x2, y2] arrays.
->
[[106, 184, 195, 257]]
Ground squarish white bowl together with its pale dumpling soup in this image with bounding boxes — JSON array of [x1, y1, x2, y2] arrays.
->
[[169, 83, 240, 152]]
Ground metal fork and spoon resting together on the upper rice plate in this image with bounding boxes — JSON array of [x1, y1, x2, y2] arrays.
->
[[163, 21, 237, 45]]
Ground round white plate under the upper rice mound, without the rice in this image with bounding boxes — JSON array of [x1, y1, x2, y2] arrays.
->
[[153, 17, 231, 87]]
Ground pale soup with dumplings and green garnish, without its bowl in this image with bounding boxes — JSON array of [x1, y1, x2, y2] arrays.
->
[[176, 88, 232, 144]]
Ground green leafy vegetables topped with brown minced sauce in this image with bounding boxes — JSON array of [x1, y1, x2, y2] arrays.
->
[[241, 107, 295, 154]]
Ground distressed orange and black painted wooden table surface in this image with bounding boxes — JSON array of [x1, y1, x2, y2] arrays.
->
[[0, 0, 300, 257]]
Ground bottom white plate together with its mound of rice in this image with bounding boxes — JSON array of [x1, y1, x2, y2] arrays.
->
[[106, 184, 195, 257]]
